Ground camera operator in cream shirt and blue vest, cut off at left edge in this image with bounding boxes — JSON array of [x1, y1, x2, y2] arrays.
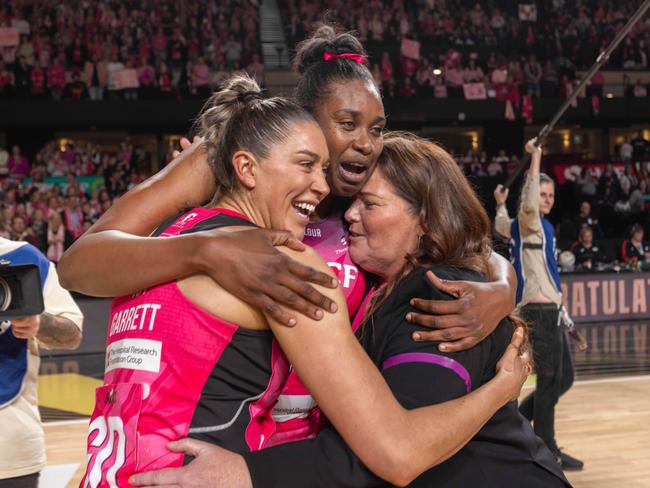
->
[[0, 238, 83, 488]]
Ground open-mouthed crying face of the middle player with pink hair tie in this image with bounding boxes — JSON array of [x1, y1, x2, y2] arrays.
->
[[314, 80, 386, 197]]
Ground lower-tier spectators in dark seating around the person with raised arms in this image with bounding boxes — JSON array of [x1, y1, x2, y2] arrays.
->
[[474, 132, 650, 269]]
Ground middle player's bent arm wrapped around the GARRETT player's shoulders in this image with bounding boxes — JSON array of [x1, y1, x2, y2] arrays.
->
[[58, 142, 336, 325]]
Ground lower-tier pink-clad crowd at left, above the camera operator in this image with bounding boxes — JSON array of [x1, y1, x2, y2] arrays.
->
[[0, 140, 151, 262]]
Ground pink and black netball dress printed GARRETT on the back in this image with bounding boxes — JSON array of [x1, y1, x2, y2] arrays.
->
[[81, 208, 289, 488]]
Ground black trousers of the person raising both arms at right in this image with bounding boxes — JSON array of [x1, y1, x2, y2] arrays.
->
[[519, 303, 573, 452]]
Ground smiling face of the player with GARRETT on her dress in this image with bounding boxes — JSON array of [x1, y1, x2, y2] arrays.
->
[[248, 122, 329, 239]]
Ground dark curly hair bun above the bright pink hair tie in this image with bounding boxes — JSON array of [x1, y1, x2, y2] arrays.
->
[[293, 24, 366, 75]]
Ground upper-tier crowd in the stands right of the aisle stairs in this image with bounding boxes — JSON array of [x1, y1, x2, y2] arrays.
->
[[282, 0, 650, 99]]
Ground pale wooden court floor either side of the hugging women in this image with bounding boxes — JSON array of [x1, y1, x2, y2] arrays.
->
[[45, 376, 650, 488]]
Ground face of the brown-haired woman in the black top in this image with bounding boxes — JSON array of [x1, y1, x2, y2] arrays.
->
[[345, 170, 422, 281]]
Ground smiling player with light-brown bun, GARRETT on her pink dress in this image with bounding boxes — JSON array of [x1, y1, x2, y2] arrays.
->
[[82, 77, 530, 487]]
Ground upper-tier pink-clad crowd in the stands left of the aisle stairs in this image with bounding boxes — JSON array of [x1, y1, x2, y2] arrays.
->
[[0, 0, 264, 100]]
